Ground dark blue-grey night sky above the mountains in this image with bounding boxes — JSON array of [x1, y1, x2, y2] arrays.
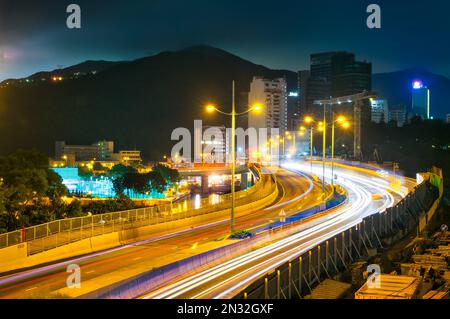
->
[[0, 0, 450, 80]]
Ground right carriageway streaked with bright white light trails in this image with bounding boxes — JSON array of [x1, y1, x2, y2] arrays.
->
[[142, 163, 414, 299]]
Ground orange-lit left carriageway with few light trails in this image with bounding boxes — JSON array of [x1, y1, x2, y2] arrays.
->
[[0, 170, 322, 298]]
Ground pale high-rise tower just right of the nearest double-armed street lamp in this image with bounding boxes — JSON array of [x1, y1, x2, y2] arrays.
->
[[248, 77, 287, 134]]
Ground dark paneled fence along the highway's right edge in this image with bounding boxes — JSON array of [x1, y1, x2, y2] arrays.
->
[[235, 172, 440, 299]]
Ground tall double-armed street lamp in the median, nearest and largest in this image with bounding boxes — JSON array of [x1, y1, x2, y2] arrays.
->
[[206, 81, 262, 234]]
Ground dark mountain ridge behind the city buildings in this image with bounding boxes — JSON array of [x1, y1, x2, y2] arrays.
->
[[0, 45, 450, 160]]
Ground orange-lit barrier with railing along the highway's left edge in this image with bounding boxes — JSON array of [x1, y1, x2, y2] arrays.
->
[[0, 168, 274, 255]]
